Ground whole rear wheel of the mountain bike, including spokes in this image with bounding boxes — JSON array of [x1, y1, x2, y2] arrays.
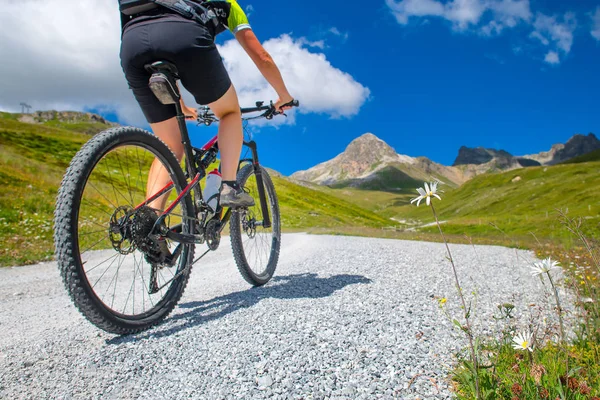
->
[[54, 128, 195, 334]]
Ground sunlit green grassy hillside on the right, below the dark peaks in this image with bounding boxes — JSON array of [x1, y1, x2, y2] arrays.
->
[[395, 162, 600, 241]]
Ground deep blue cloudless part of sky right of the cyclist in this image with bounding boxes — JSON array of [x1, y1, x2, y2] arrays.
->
[[195, 1, 600, 174]]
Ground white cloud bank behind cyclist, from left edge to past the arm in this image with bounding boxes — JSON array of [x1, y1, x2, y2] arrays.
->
[[0, 0, 369, 125]]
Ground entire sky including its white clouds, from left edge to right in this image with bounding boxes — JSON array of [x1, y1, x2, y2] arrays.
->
[[0, 0, 600, 174]]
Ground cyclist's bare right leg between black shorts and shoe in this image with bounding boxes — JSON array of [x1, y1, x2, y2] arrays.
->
[[208, 85, 244, 181]]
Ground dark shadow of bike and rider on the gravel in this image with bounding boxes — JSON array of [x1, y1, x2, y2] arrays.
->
[[106, 273, 371, 344]]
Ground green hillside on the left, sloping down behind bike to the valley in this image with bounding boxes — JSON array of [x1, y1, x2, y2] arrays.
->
[[0, 113, 388, 266]]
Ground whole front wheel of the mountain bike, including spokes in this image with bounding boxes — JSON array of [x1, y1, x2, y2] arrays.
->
[[230, 164, 281, 286]]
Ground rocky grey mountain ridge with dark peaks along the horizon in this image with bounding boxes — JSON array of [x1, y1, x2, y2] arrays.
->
[[290, 132, 600, 191]]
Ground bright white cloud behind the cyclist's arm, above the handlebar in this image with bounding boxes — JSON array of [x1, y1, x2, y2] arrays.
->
[[219, 35, 370, 117]]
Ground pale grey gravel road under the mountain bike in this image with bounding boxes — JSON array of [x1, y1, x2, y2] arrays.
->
[[0, 234, 568, 399]]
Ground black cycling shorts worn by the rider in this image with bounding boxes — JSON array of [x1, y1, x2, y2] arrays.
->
[[121, 15, 231, 123]]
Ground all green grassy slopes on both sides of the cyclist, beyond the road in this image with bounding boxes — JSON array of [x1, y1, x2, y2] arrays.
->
[[0, 109, 600, 265]]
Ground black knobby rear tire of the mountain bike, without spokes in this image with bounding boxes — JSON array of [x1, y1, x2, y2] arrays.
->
[[54, 127, 194, 335]]
